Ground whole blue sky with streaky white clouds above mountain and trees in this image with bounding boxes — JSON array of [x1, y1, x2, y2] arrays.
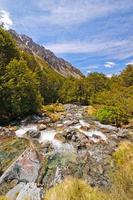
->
[[0, 0, 133, 77]]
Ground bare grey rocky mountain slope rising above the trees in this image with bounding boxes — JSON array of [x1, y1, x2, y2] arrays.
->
[[9, 30, 83, 78]]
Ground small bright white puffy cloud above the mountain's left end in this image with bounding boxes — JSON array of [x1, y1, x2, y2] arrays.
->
[[0, 10, 13, 29]]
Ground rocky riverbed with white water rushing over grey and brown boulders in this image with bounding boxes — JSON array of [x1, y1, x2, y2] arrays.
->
[[0, 105, 129, 200]]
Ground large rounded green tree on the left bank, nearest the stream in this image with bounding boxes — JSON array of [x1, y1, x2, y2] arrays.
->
[[0, 59, 41, 118]]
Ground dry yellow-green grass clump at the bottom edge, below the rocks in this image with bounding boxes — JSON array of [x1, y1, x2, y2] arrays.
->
[[45, 178, 108, 200]]
